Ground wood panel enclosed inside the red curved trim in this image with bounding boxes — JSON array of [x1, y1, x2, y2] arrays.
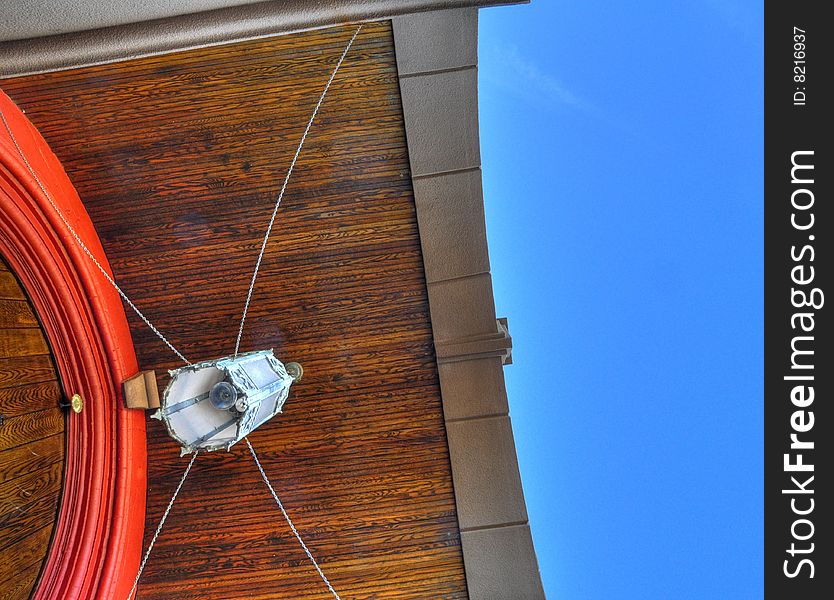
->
[[0, 259, 64, 600]]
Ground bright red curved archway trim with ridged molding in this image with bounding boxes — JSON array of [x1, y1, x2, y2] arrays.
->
[[0, 91, 147, 600]]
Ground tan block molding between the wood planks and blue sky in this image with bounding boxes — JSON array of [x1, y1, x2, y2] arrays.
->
[[393, 9, 544, 600]]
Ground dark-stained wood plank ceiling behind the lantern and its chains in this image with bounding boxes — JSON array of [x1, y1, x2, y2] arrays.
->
[[0, 22, 467, 600]]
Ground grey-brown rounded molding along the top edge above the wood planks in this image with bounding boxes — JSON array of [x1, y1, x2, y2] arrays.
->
[[0, 0, 529, 79]]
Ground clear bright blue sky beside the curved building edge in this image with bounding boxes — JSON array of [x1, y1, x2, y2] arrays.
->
[[479, 0, 763, 600]]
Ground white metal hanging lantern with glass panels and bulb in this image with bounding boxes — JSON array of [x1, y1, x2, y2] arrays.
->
[[152, 350, 303, 454]]
